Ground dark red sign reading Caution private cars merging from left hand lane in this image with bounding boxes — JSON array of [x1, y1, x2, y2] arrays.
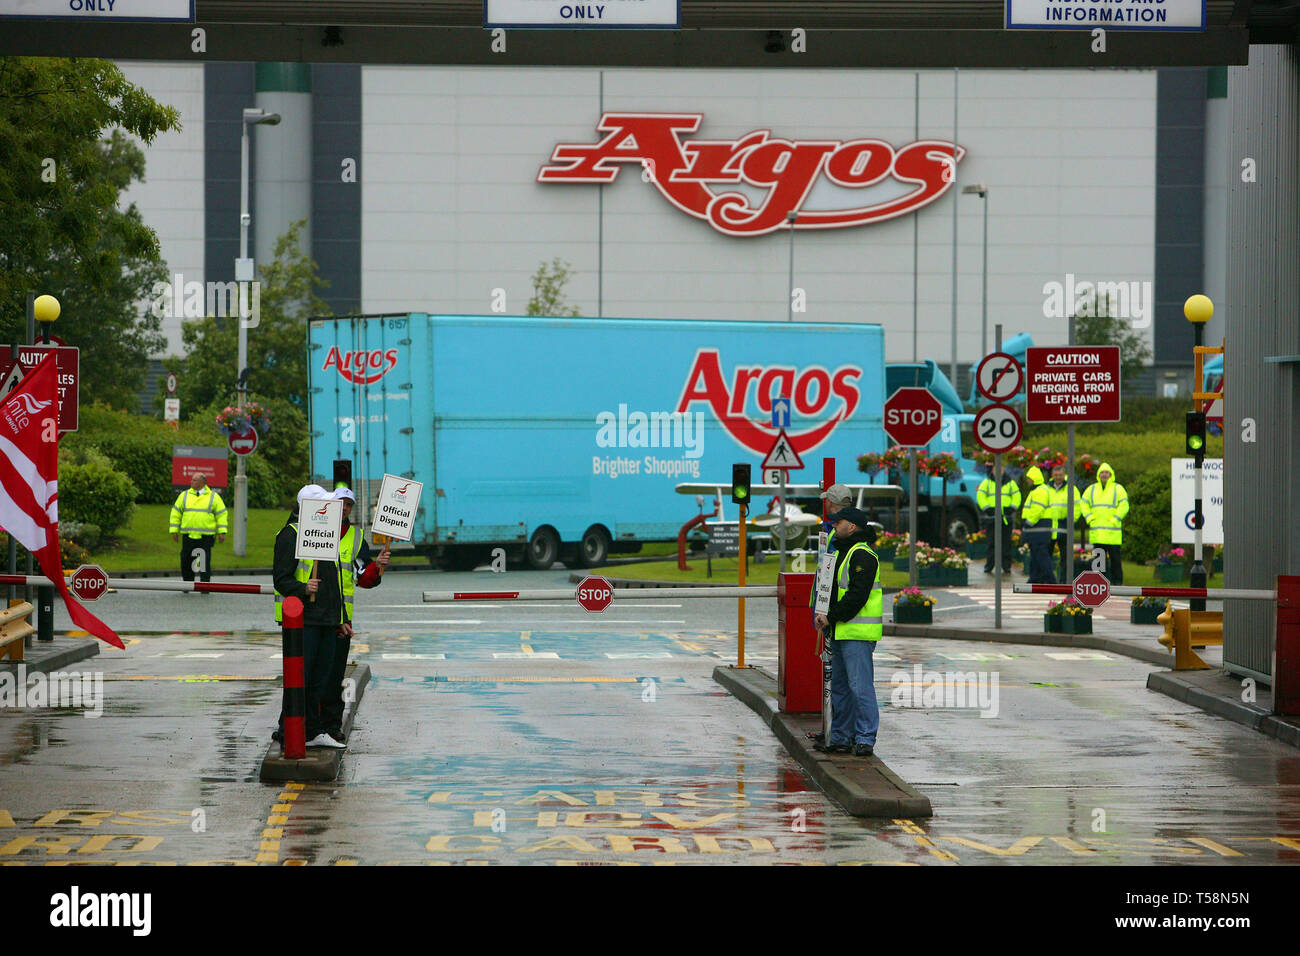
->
[[1024, 345, 1119, 424]]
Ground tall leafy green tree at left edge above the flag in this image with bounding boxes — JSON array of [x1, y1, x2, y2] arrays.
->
[[0, 57, 181, 405]]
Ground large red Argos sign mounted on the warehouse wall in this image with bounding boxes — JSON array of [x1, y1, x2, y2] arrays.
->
[[537, 113, 966, 235]]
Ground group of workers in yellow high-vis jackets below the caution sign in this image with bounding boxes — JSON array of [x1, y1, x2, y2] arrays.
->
[[975, 462, 1128, 584]]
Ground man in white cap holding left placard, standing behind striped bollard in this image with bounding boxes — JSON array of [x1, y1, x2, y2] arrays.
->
[[272, 485, 352, 749]]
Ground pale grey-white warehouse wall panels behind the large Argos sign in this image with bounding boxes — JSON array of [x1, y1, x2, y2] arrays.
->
[[360, 66, 1156, 362]]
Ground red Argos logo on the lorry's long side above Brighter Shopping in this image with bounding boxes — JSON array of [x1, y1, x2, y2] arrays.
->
[[676, 349, 862, 455]]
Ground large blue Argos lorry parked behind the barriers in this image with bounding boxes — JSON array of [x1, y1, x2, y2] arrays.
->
[[307, 313, 979, 568]]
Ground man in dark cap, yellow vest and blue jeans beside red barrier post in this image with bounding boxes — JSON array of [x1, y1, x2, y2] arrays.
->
[[815, 507, 884, 757]]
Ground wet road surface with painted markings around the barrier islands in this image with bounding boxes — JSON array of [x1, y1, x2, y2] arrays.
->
[[0, 570, 1300, 866]]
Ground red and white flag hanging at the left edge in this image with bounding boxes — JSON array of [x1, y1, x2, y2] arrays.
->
[[0, 352, 122, 648]]
